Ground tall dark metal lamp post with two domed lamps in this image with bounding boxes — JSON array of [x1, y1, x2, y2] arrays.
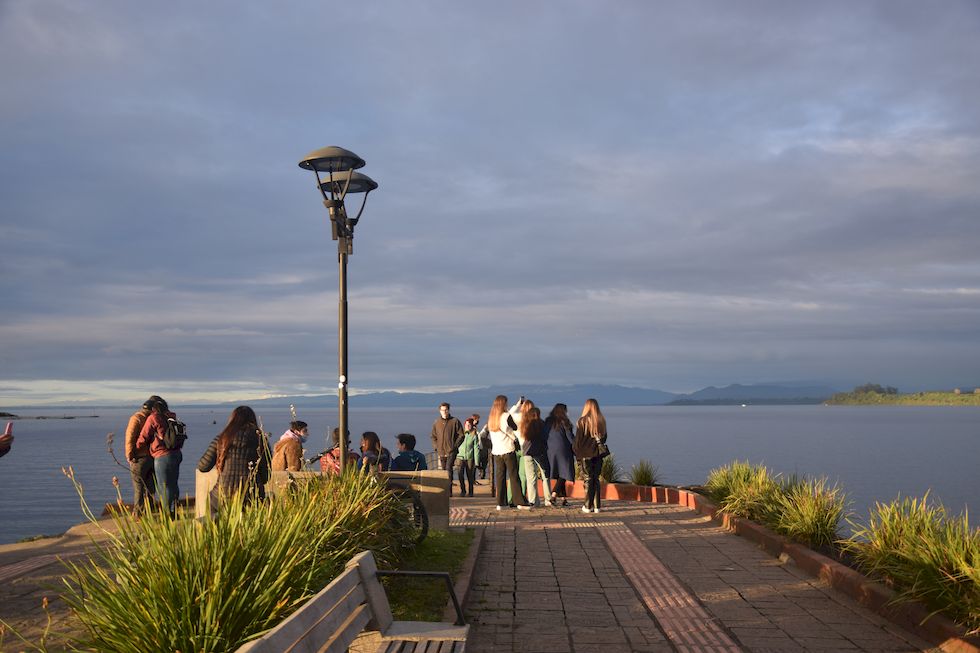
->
[[299, 146, 378, 474]]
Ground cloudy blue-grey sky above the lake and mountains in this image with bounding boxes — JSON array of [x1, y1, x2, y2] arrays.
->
[[0, 0, 980, 407]]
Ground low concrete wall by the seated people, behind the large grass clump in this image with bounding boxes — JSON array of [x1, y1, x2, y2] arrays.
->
[[194, 469, 449, 531]]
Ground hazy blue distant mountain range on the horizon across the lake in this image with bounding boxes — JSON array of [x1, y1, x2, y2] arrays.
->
[[239, 384, 837, 408]]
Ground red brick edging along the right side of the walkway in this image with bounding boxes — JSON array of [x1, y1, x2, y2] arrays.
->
[[548, 481, 980, 653]]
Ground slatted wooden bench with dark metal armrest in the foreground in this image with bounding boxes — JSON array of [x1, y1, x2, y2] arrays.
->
[[237, 551, 470, 653]]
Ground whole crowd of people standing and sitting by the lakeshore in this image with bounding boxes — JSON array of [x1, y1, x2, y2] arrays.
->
[[119, 395, 607, 514]]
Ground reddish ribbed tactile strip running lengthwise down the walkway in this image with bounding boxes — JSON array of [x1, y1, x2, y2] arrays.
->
[[596, 515, 742, 652]]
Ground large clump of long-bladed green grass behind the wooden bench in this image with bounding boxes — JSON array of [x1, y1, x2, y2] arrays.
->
[[64, 466, 412, 651]]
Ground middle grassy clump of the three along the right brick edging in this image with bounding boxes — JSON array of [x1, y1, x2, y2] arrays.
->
[[771, 476, 848, 547]]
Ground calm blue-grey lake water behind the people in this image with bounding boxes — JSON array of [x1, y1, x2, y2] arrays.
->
[[0, 406, 980, 543]]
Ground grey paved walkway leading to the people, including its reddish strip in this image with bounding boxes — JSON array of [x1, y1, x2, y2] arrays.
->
[[452, 478, 936, 653]]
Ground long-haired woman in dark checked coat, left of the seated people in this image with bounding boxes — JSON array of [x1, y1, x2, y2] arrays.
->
[[197, 406, 269, 503]]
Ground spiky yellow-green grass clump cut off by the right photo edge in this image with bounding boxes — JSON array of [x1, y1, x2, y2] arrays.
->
[[845, 492, 980, 634]]
